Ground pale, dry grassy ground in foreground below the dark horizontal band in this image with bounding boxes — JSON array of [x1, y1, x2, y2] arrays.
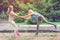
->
[[0, 32, 60, 40]]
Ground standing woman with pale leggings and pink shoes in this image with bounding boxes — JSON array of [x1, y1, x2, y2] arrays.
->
[[7, 5, 20, 37]]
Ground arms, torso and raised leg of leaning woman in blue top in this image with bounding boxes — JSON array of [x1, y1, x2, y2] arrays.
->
[[20, 9, 56, 28]]
